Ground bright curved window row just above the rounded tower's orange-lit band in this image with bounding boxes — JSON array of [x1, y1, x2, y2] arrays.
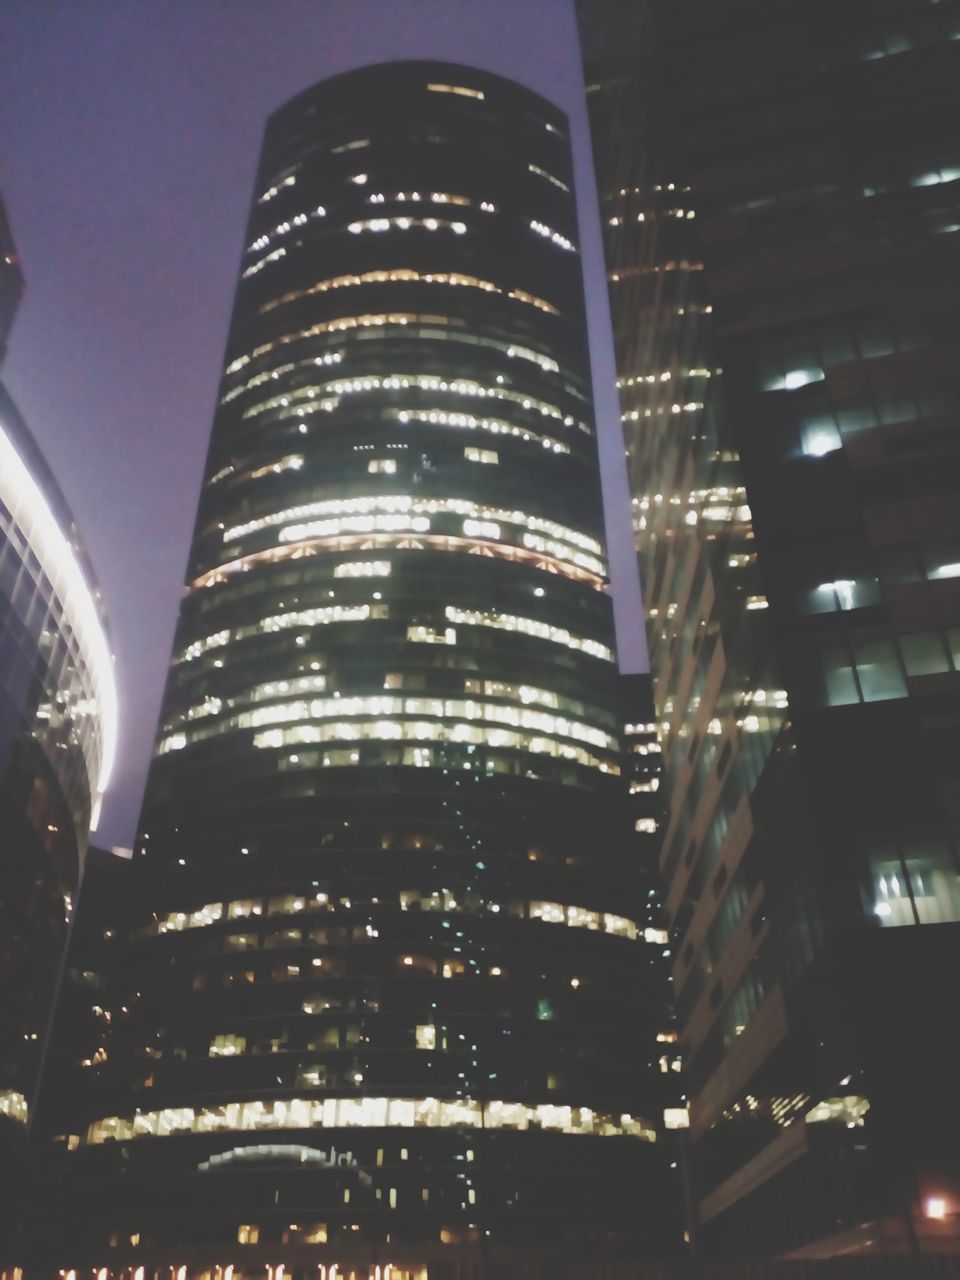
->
[[223, 494, 604, 563]]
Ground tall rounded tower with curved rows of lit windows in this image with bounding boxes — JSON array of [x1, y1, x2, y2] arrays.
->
[[48, 63, 678, 1276]]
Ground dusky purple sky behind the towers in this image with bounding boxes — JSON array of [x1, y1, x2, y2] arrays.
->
[[0, 0, 645, 845]]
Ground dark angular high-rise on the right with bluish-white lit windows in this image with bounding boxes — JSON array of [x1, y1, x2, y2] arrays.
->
[[579, 0, 960, 1254]]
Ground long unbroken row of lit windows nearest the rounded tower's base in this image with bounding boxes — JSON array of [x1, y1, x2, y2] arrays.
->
[[83, 1098, 657, 1146]]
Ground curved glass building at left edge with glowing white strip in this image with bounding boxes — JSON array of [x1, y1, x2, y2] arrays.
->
[[0, 192, 116, 1262]]
